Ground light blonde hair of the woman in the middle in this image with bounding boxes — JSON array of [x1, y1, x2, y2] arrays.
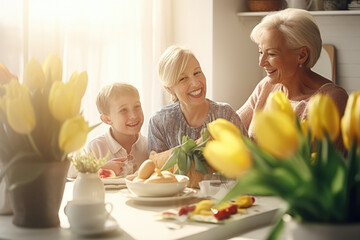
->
[[159, 46, 195, 102]]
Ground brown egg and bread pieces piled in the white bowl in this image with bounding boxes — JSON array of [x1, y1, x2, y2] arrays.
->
[[133, 159, 186, 183]]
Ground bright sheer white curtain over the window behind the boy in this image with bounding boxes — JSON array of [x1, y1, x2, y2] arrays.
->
[[0, 0, 172, 140]]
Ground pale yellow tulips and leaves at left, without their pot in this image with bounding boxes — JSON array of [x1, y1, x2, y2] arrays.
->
[[0, 55, 98, 189]]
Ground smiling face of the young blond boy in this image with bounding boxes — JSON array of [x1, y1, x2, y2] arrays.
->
[[105, 94, 144, 135]]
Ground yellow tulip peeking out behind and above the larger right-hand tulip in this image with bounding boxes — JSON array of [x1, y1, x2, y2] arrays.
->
[[264, 91, 295, 120]]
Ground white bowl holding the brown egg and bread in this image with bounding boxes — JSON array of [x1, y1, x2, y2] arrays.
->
[[125, 174, 189, 197]]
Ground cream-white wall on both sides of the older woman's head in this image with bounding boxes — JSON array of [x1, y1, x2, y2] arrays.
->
[[174, 0, 360, 109]]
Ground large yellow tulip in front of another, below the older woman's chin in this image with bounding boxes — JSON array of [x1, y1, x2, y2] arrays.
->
[[254, 110, 300, 159]]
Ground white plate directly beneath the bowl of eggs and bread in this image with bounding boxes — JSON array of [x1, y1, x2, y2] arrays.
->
[[119, 188, 197, 202]]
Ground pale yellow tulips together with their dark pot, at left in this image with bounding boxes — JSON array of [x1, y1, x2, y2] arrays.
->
[[0, 54, 98, 227]]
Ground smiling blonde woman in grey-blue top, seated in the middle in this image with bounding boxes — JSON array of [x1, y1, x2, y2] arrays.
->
[[148, 46, 247, 152]]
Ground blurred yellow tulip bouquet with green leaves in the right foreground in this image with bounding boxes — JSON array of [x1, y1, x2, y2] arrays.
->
[[203, 91, 360, 237]]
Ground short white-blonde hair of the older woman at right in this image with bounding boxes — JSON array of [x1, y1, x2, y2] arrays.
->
[[250, 8, 322, 68]]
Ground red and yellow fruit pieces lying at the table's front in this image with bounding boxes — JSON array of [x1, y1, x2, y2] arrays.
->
[[162, 194, 255, 222]]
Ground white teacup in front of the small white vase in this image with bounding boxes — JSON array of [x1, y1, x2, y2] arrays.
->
[[64, 201, 112, 231]]
